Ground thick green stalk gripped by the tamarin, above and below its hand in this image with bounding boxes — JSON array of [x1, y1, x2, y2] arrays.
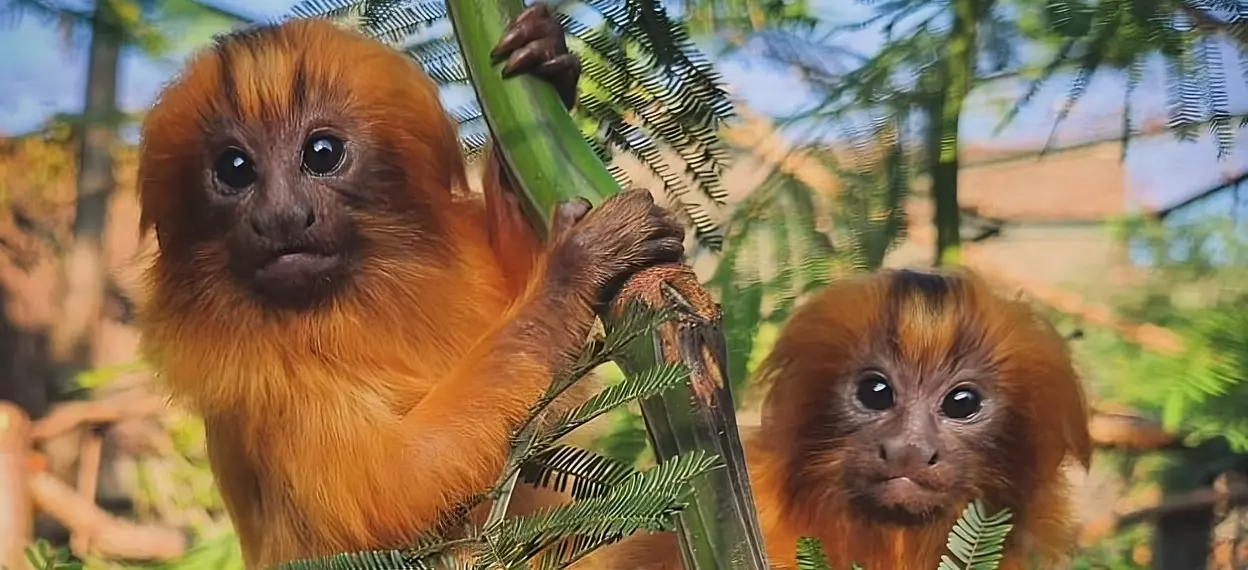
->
[[448, 0, 766, 570]]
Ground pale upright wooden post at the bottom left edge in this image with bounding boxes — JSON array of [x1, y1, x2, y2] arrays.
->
[[0, 400, 32, 569]]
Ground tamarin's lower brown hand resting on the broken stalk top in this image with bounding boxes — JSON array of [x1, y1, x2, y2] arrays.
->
[[549, 190, 685, 307]]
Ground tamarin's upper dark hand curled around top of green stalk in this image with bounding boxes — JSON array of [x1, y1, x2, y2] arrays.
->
[[489, 1, 580, 109]]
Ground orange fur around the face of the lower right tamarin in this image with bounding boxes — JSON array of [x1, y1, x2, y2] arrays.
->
[[746, 271, 1091, 570]]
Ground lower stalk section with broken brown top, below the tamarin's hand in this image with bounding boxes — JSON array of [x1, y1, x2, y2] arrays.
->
[[615, 266, 768, 570]]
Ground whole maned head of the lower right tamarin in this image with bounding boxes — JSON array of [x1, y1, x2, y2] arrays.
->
[[758, 271, 1091, 535]]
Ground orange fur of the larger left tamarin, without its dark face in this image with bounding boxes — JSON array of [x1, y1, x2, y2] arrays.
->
[[139, 20, 593, 568]]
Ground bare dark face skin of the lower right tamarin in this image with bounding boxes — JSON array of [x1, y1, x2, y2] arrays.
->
[[836, 360, 1005, 525]]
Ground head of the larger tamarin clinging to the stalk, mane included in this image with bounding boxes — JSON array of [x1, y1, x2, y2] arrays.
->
[[140, 20, 464, 311]]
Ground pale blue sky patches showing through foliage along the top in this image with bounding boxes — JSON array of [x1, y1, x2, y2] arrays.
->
[[0, 0, 1248, 213]]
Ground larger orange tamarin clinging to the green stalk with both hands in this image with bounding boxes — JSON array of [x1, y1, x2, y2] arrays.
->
[[139, 5, 684, 569]]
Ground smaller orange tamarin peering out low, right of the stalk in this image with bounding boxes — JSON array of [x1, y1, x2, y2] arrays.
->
[[584, 271, 1091, 570]]
